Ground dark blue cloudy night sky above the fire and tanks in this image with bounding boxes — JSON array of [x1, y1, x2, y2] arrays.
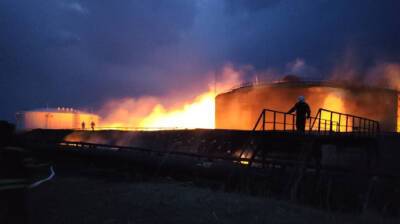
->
[[0, 0, 400, 121]]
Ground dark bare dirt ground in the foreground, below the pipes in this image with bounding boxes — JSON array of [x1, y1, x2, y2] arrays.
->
[[28, 176, 399, 224]]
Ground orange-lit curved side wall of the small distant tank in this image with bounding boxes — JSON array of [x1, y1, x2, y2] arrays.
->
[[18, 111, 99, 130]]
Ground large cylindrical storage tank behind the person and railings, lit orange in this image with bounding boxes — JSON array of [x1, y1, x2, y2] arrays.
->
[[215, 81, 399, 132]]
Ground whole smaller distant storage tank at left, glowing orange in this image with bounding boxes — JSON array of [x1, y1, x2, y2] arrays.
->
[[16, 107, 100, 130]]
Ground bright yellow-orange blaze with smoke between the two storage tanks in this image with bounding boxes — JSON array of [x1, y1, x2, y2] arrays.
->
[[101, 66, 242, 130]]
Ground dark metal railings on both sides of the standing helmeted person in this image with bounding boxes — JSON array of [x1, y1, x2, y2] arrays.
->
[[253, 108, 379, 134]]
